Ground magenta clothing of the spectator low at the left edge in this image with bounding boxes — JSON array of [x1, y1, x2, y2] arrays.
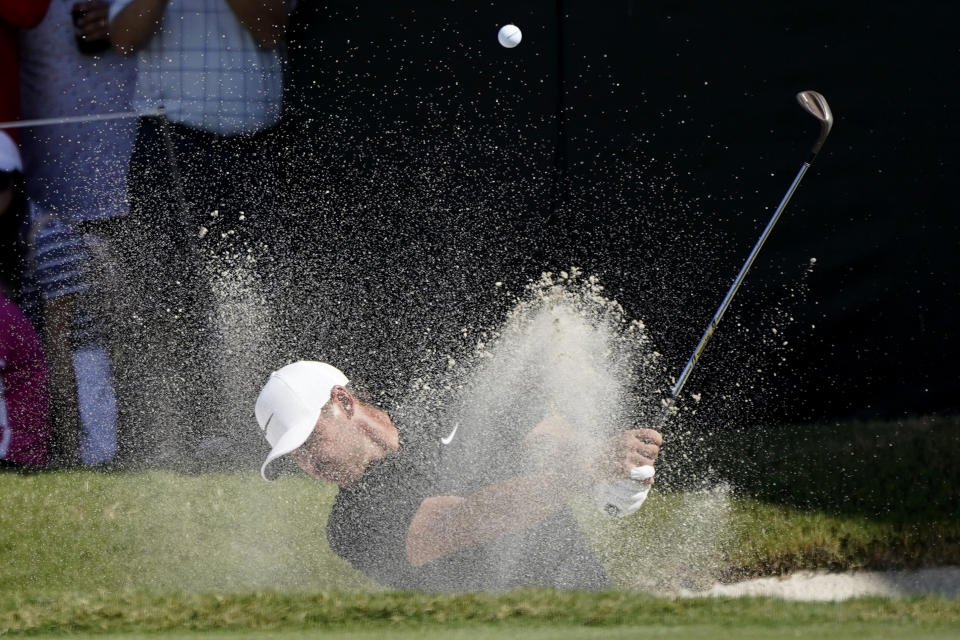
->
[[0, 292, 50, 467]]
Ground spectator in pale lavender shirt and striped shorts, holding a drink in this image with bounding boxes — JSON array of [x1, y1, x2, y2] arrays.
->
[[20, 0, 135, 464]]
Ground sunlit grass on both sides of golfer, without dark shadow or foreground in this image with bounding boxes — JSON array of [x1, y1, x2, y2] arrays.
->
[[0, 471, 960, 593]]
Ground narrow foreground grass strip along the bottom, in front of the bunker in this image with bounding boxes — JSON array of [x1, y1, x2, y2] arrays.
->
[[0, 590, 960, 637]]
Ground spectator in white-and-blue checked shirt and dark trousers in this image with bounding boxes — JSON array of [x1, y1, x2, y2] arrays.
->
[[110, 0, 291, 464]]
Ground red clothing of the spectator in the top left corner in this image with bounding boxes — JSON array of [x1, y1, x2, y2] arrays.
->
[[0, 0, 50, 141]]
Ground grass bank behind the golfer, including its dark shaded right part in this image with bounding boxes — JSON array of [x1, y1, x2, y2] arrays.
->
[[0, 418, 960, 594]]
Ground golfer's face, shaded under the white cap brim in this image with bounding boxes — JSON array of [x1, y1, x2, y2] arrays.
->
[[294, 415, 367, 485]]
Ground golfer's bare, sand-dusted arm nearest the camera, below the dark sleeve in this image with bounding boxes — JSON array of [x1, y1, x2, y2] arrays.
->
[[406, 474, 571, 567]]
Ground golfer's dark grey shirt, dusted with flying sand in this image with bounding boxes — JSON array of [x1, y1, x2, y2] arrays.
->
[[327, 412, 608, 591]]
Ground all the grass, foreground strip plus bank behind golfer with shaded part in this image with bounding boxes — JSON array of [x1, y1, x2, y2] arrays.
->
[[0, 418, 960, 640]]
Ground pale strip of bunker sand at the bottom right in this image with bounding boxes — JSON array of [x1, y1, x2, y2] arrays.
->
[[682, 567, 960, 602]]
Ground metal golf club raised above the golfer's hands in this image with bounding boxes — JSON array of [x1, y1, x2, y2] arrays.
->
[[670, 91, 833, 398]]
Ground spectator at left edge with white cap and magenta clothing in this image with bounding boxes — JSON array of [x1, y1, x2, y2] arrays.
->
[[0, 131, 50, 467]]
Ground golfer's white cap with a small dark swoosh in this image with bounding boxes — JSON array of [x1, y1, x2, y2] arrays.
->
[[254, 360, 349, 481]]
